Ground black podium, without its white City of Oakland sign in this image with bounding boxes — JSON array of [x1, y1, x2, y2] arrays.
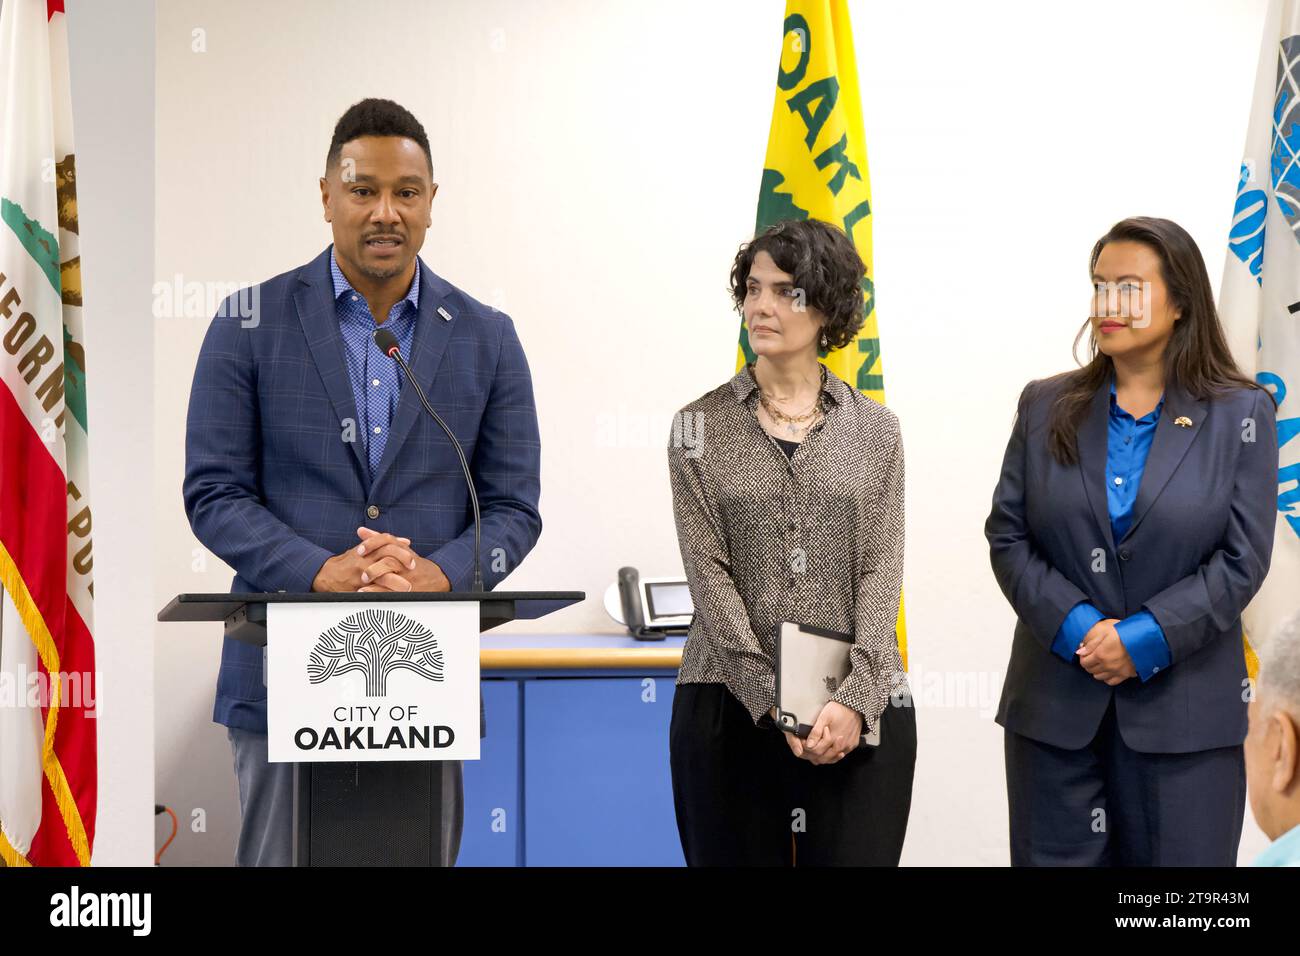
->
[[157, 591, 586, 866]]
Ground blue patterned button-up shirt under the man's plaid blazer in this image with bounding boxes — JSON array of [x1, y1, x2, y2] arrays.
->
[[329, 246, 420, 477]]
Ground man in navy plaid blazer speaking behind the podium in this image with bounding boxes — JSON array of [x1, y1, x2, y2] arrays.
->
[[183, 99, 542, 865]]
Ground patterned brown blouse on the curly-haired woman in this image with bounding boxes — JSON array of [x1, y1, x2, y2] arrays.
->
[[668, 367, 907, 732]]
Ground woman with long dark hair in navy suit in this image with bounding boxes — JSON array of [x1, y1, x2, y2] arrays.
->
[[984, 219, 1278, 866]]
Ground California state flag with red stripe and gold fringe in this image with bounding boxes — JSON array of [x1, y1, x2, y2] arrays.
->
[[0, 0, 96, 866]]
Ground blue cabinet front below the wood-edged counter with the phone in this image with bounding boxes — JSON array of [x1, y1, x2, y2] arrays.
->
[[456, 671, 684, 866]]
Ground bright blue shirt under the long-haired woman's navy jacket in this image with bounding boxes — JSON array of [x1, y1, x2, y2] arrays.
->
[[1052, 377, 1173, 683]]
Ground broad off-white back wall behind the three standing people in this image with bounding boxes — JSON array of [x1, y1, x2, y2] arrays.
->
[[152, 0, 1265, 865]]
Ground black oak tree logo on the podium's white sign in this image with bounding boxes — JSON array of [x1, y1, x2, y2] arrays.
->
[[307, 609, 442, 697]]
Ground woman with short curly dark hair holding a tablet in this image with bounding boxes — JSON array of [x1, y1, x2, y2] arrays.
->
[[668, 220, 917, 865]]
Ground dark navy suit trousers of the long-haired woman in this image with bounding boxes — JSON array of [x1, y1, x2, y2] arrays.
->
[[1006, 700, 1245, 866]]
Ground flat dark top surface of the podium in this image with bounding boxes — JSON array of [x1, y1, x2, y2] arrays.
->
[[157, 591, 586, 622]]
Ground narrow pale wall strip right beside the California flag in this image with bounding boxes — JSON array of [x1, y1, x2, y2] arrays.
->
[[66, 0, 155, 866]]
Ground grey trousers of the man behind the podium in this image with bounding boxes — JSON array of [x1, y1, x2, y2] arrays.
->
[[226, 727, 465, 866]]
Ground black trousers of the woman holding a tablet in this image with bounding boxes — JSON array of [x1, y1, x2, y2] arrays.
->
[[668, 684, 917, 866]]
